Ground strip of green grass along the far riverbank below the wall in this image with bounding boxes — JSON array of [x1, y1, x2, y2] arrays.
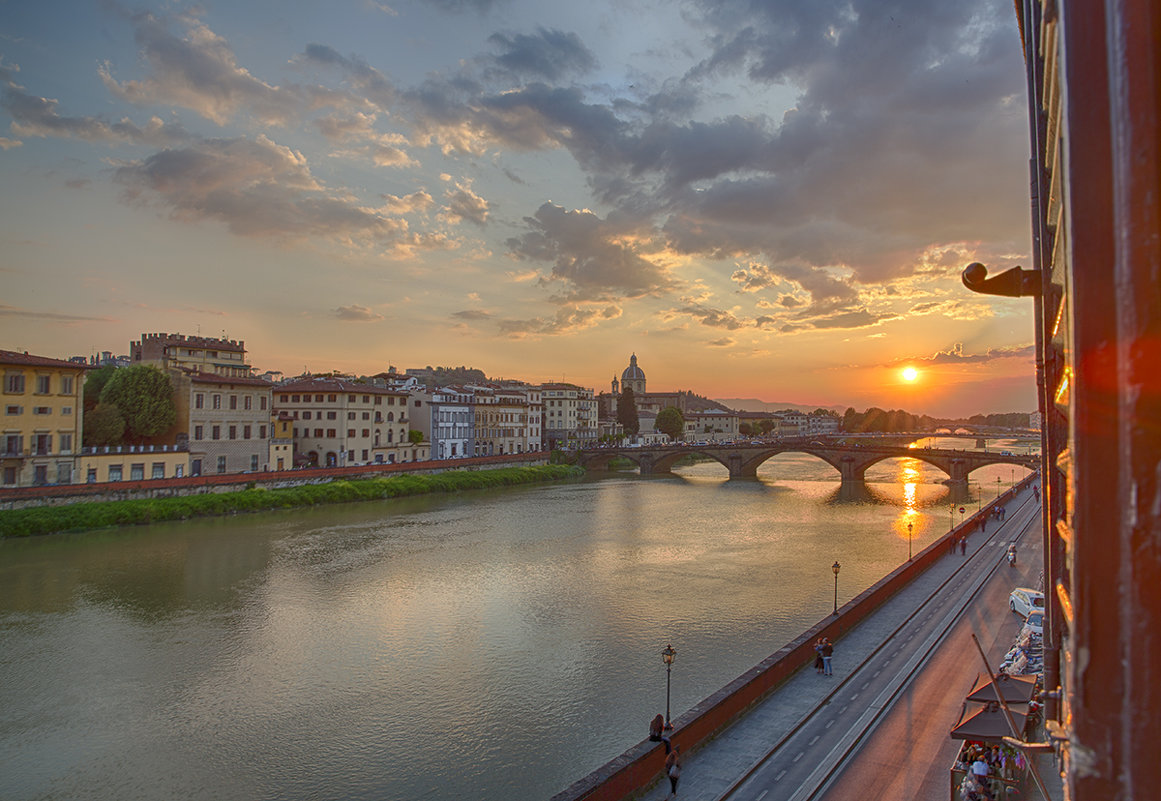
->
[[0, 464, 584, 537]]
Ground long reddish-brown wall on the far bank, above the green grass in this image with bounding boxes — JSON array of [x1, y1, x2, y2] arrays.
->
[[0, 452, 548, 510]]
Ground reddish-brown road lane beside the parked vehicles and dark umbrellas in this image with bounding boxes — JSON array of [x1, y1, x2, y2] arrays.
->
[[821, 537, 1043, 801]]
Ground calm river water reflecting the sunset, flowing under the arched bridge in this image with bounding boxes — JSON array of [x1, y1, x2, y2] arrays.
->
[[0, 440, 1024, 801]]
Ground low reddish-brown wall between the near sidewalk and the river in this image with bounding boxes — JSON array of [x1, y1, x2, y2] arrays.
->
[[551, 474, 1039, 801]]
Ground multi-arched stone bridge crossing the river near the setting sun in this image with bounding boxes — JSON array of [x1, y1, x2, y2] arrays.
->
[[577, 438, 1040, 484]]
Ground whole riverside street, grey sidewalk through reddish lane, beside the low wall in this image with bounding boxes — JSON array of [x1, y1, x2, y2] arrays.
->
[[554, 481, 1062, 801]]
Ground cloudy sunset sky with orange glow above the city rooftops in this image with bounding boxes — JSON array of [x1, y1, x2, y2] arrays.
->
[[0, 0, 1036, 416]]
